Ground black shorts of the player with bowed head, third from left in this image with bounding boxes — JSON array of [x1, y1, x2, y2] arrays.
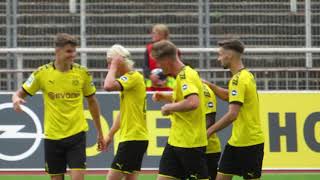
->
[[159, 144, 208, 180]]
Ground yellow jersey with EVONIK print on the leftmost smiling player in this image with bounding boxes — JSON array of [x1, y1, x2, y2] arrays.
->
[[22, 62, 96, 140]]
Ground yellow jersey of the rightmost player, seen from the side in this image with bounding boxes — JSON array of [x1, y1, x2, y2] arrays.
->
[[228, 69, 264, 147]]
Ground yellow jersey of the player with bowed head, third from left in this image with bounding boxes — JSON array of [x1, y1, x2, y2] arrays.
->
[[168, 66, 208, 148]]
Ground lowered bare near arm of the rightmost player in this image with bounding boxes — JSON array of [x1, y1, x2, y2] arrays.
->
[[207, 103, 241, 137]]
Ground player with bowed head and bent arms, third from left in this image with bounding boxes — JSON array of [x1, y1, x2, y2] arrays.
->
[[152, 40, 208, 180]]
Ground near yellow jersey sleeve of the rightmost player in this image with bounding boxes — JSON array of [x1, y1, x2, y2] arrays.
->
[[229, 75, 246, 104]]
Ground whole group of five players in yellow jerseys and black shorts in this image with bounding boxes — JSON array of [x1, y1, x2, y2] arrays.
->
[[12, 31, 264, 180]]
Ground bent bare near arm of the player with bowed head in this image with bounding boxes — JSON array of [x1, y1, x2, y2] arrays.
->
[[161, 94, 200, 115]]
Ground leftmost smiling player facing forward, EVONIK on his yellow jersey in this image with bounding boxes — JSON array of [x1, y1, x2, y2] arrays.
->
[[12, 33, 105, 180]]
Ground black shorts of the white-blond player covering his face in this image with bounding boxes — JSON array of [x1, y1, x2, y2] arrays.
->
[[111, 141, 148, 174]]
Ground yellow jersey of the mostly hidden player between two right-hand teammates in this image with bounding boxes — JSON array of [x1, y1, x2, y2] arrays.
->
[[203, 83, 221, 154]]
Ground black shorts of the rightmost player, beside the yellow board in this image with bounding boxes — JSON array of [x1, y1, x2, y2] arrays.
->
[[218, 143, 264, 179]]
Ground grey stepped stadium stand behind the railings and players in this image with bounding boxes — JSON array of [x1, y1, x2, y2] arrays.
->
[[0, 0, 320, 90]]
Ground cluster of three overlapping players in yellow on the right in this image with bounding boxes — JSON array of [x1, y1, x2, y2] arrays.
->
[[152, 39, 264, 180]]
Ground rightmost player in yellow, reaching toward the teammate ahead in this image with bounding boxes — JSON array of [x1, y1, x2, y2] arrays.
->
[[207, 39, 264, 180]]
